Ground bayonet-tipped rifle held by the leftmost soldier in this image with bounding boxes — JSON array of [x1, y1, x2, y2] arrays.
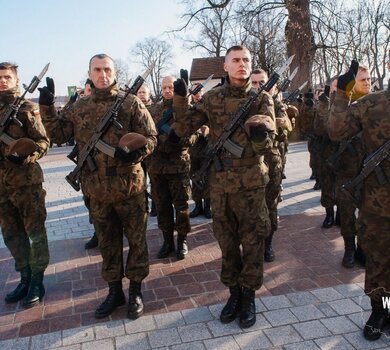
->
[[0, 63, 50, 145]]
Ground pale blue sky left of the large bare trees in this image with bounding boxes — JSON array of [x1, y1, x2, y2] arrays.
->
[[0, 0, 200, 96]]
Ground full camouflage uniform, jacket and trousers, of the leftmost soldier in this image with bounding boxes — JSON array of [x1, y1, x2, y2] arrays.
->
[[0, 89, 49, 275]]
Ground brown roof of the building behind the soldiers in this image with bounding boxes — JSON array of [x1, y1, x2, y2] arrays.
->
[[190, 56, 226, 80]]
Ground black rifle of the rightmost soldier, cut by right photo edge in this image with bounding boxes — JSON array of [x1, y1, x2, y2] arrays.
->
[[341, 140, 390, 205]]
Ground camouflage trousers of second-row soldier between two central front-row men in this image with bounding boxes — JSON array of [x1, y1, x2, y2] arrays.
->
[[149, 173, 191, 235]]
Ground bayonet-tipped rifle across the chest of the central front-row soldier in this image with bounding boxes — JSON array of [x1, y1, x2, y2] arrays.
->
[[192, 55, 294, 189]]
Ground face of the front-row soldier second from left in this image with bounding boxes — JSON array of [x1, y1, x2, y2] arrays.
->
[[89, 57, 115, 89]]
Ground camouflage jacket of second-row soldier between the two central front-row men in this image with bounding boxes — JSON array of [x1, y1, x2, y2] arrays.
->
[[146, 99, 190, 174]]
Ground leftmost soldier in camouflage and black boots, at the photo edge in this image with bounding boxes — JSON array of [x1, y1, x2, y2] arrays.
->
[[0, 62, 49, 308]]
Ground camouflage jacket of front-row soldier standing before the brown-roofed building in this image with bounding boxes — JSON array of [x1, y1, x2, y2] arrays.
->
[[173, 79, 275, 193]]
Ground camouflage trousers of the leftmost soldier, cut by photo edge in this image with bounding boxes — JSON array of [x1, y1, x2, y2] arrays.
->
[[0, 184, 49, 274]]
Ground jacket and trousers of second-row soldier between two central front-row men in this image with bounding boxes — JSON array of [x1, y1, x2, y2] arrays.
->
[[146, 99, 191, 245]]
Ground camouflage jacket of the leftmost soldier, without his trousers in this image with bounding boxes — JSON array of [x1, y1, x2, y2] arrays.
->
[[0, 89, 49, 189]]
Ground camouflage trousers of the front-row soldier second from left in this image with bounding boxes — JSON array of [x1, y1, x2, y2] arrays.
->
[[90, 192, 149, 282]]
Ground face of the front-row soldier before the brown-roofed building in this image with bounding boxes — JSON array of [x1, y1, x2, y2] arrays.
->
[[224, 50, 252, 86]]
